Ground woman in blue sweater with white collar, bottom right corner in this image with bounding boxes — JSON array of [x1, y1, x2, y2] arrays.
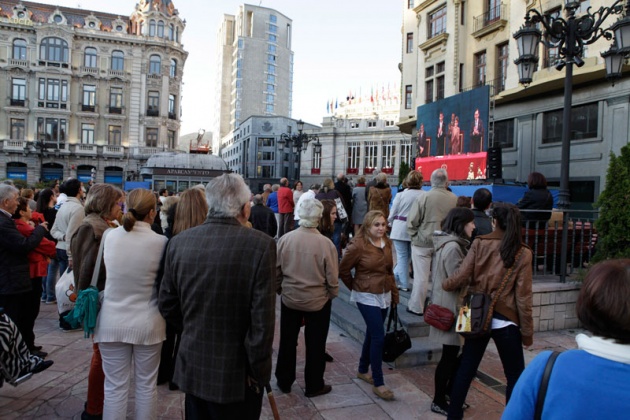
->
[[503, 259, 630, 419]]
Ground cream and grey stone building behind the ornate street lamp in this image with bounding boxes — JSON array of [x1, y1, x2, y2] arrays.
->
[[399, 0, 630, 203]]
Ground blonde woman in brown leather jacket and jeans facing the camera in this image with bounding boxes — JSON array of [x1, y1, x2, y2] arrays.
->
[[339, 211, 398, 400]]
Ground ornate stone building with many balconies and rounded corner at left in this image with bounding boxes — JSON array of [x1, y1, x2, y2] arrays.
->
[[0, 0, 188, 185]]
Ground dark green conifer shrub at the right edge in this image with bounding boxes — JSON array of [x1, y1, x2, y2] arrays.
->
[[593, 144, 630, 261]]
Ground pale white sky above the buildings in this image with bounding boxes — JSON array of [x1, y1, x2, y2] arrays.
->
[[48, 0, 403, 135]]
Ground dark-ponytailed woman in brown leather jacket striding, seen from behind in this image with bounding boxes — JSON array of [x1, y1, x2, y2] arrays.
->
[[442, 204, 534, 419]]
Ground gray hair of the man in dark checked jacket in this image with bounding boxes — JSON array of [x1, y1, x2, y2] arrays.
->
[[206, 174, 251, 218]]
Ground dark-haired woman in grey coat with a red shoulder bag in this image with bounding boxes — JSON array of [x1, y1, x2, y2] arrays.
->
[[429, 207, 475, 415]]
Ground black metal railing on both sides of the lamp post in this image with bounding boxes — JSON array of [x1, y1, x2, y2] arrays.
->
[[521, 209, 599, 277]]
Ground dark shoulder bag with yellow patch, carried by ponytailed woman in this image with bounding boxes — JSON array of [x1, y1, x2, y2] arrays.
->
[[455, 247, 524, 338]]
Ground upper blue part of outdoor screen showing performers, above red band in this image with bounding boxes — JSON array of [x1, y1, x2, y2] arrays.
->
[[416, 86, 490, 157]]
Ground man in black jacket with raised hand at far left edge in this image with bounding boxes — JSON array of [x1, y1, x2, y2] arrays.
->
[[0, 184, 48, 357]]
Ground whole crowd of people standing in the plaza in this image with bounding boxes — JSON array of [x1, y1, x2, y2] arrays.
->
[[0, 169, 630, 419]]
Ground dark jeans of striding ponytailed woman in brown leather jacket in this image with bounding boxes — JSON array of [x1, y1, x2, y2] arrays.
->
[[448, 325, 525, 419]]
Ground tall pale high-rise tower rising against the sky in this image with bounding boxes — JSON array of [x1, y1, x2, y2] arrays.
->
[[213, 4, 293, 153]]
